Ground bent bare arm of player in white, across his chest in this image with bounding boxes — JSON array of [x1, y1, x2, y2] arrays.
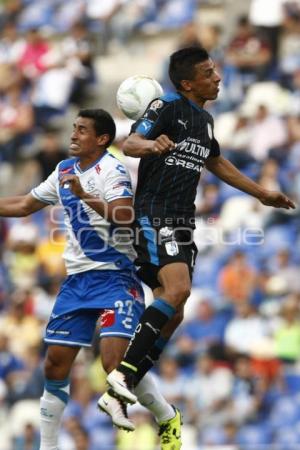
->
[[60, 174, 134, 226]]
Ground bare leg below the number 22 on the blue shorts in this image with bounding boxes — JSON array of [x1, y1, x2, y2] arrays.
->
[[100, 336, 129, 373]]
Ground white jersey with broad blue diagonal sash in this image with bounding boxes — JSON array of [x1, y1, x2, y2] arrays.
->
[[31, 151, 136, 275]]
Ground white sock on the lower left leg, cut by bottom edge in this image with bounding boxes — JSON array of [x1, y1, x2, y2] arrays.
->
[[40, 390, 66, 450]]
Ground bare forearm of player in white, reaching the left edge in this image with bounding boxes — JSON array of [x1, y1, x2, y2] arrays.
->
[[0, 194, 48, 217]]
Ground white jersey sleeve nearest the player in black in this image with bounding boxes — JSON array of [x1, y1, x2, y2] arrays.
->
[[104, 158, 133, 203]]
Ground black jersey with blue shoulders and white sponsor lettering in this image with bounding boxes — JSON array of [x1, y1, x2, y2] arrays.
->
[[131, 93, 220, 227]]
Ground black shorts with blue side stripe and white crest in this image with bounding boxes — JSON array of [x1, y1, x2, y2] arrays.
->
[[134, 216, 198, 290]]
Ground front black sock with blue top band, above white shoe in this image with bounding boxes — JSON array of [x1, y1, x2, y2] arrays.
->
[[119, 299, 175, 375]]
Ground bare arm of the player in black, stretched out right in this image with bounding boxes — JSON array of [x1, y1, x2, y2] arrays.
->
[[206, 156, 296, 209]]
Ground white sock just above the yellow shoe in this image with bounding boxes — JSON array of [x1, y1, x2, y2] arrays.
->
[[134, 373, 175, 423]]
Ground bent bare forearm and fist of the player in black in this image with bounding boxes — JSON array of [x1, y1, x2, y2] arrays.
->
[[123, 133, 175, 158]]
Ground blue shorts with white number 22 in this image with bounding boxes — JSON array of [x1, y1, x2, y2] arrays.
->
[[44, 270, 145, 347]]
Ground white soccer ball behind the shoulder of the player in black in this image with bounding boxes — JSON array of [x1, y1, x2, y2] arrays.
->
[[117, 75, 163, 120]]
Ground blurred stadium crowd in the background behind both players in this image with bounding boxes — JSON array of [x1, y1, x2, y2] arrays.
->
[[0, 0, 300, 450]]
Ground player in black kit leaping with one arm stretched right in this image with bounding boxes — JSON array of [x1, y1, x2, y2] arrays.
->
[[103, 47, 295, 449]]
